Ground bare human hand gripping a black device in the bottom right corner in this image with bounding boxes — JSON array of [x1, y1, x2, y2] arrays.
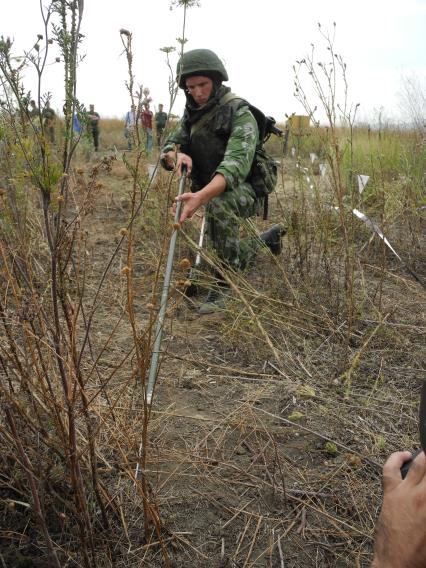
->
[[371, 452, 426, 568]]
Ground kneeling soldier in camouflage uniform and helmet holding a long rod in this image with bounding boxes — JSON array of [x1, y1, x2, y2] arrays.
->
[[162, 49, 284, 314]]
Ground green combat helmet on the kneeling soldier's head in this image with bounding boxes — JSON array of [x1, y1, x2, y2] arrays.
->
[[176, 49, 228, 89]]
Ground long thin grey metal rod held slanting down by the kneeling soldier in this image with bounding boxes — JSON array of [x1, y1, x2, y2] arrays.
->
[[146, 172, 186, 405]]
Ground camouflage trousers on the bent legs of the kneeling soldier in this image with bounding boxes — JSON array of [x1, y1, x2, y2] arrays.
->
[[206, 183, 259, 270]]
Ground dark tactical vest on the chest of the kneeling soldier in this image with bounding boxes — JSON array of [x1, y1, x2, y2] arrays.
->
[[183, 95, 247, 191]]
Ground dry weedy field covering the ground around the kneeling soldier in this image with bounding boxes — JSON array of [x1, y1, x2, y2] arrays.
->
[[0, 3, 426, 568]]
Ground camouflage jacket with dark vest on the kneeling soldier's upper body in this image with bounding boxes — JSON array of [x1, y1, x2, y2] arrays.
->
[[163, 87, 258, 191]]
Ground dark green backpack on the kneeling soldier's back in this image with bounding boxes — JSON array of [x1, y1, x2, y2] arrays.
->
[[220, 93, 282, 219]]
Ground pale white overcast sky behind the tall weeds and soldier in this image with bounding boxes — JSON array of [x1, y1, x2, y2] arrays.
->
[[0, 0, 426, 121]]
